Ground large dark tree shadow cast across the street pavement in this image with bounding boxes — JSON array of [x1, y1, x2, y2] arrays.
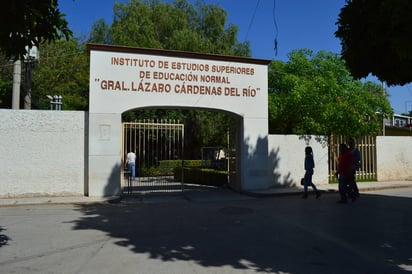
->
[[69, 191, 412, 274]]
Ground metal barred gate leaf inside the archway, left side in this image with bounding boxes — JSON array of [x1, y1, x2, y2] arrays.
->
[[121, 120, 184, 194]]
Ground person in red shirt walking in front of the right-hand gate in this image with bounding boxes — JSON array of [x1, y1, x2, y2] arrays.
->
[[337, 144, 354, 204]]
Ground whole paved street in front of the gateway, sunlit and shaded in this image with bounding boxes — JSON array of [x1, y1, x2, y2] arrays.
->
[[0, 188, 412, 274]]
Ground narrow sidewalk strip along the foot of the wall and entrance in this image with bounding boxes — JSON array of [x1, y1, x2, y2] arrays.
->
[[0, 181, 412, 207]]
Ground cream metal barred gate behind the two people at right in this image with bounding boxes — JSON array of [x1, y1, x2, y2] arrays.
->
[[329, 136, 377, 182]]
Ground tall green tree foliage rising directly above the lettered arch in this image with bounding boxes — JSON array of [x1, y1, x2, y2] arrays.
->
[[89, 0, 250, 56]]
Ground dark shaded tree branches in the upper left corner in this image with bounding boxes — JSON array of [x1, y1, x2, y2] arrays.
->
[[0, 0, 72, 59]]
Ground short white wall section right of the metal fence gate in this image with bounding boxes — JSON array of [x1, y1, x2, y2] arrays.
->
[[376, 136, 412, 181]]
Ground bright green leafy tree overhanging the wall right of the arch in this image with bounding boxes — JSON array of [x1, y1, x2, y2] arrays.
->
[[269, 49, 392, 137]]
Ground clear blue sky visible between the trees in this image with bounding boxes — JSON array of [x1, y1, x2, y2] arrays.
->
[[59, 0, 412, 114]]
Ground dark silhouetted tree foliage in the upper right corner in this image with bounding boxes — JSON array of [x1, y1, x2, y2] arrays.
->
[[335, 0, 412, 86]]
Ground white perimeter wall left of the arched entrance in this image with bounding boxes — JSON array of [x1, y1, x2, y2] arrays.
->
[[0, 109, 85, 197]]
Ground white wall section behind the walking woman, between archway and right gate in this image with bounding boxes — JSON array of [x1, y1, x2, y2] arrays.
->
[[268, 135, 328, 187]]
